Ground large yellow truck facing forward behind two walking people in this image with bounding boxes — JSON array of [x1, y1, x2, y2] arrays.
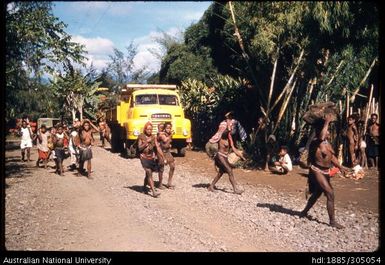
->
[[106, 84, 191, 157]]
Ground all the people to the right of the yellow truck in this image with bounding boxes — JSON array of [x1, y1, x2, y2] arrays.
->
[[206, 112, 379, 229]]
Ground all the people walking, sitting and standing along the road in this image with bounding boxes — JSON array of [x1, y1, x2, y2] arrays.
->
[[19, 108, 379, 229]]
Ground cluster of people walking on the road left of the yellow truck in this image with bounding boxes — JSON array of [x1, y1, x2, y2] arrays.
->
[[19, 119, 101, 179]]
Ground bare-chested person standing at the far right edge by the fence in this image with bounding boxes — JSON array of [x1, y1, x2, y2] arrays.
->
[[367, 113, 380, 167]]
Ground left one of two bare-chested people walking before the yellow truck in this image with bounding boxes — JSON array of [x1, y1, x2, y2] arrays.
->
[[138, 122, 164, 198]]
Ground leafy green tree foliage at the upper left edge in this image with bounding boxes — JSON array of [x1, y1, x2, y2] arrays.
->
[[5, 2, 84, 119]]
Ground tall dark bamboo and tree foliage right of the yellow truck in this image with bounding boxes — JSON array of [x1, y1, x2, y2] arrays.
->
[[160, 2, 379, 150]]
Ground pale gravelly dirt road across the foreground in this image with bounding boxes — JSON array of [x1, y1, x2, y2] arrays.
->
[[5, 139, 379, 252]]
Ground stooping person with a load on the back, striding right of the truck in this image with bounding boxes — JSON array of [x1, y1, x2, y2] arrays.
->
[[208, 123, 246, 194]]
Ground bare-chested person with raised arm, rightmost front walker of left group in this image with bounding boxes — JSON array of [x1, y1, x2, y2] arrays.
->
[[78, 120, 98, 179]]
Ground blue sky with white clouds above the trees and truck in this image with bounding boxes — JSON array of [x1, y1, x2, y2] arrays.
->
[[53, 1, 211, 71]]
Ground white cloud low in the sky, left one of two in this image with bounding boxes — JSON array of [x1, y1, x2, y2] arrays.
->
[[72, 35, 115, 70]]
